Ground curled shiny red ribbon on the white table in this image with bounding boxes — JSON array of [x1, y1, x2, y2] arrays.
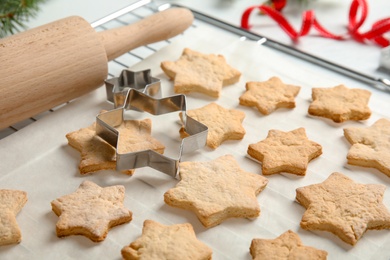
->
[[241, 0, 390, 47]]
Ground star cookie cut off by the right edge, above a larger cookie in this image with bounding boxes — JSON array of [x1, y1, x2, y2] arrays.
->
[[344, 118, 390, 177]]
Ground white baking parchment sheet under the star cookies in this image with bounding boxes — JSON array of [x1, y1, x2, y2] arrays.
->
[[0, 20, 390, 259]]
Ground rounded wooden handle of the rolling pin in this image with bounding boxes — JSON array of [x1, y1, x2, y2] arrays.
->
[[99, 8, 194, 61]]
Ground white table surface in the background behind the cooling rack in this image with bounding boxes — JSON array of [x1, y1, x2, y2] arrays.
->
[[24, 0, 390, 77]]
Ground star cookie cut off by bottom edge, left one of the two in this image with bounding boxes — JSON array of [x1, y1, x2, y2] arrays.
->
[[122, 220, 212, 260]]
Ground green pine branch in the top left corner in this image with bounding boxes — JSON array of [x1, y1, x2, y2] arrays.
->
[[0, 0, 46, 38]]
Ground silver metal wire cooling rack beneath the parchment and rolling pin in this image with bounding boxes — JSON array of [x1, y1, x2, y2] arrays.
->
[[0, 0, 390, 139]]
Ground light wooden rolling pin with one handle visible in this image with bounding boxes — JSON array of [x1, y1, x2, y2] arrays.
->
[[0, 8, 193, 129]]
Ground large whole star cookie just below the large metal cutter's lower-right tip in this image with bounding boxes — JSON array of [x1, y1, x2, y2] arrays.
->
[[164, 155, 268, 227]]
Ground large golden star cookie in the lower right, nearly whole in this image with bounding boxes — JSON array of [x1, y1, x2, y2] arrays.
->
[[296, 172, 390, 245]]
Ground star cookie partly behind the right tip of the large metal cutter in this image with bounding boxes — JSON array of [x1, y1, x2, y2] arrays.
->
[[180, 103, 246, 149]]
